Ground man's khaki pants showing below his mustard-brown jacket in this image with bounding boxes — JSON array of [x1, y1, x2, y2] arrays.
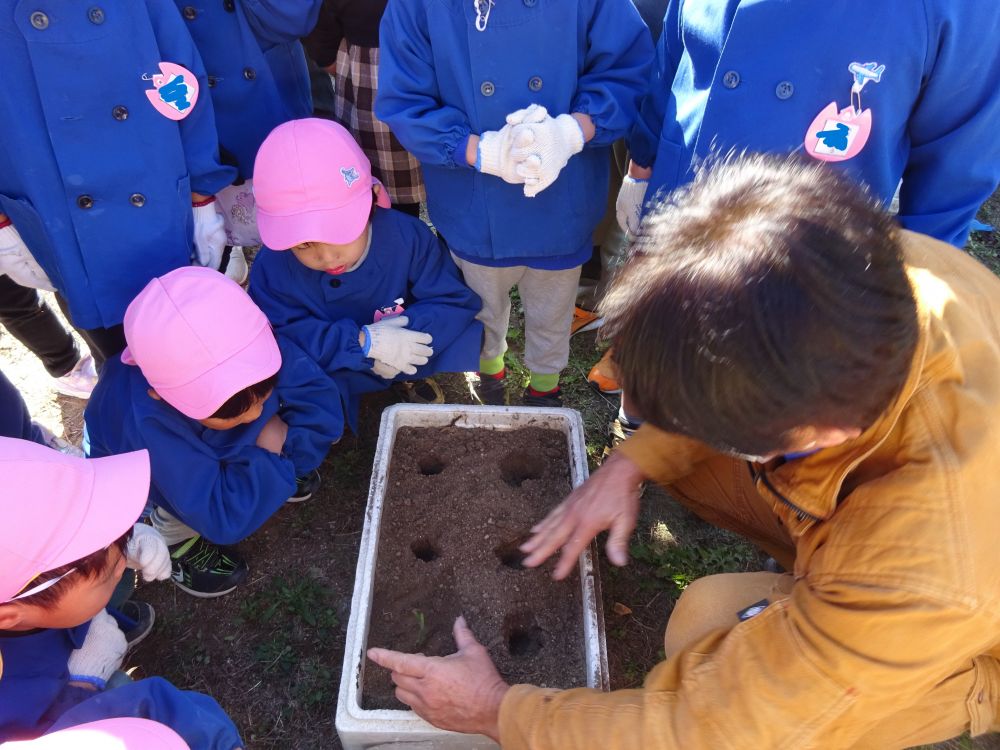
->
[[663, 456, 1000, 750]]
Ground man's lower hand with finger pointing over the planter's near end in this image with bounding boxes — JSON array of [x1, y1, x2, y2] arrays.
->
[[368, 617, 510, 742]]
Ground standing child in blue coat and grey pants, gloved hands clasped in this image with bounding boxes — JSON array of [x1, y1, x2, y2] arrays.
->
[[375, 0, 653, 406]]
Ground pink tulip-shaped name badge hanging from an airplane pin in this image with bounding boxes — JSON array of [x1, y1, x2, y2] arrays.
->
[[803, 62, 885, 162]]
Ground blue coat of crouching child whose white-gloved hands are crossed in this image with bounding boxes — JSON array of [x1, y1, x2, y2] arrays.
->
[[250, 208, 483, 426]]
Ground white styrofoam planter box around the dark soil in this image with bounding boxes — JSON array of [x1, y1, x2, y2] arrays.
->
[[336, 404, 608, 750]]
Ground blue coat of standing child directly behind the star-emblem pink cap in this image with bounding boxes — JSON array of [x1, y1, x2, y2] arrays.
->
[[174, 0, 322, 179]]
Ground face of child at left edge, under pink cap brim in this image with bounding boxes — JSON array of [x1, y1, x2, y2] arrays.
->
[[0, 544, 125, 631]]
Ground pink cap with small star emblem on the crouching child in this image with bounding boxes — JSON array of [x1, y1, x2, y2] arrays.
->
[[253, 117, 390, 250]]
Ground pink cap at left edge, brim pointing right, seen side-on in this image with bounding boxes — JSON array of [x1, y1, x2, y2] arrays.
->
[[0, 438, 149, 602]]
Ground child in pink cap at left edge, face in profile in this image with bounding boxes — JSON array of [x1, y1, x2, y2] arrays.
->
[[0, 437, 242, 750]]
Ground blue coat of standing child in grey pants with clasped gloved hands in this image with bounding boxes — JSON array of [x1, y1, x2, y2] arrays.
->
[[375, 0, 653, 268]]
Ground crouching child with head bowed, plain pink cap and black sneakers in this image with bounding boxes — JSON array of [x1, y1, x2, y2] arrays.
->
[[84, 267, 343, 597]]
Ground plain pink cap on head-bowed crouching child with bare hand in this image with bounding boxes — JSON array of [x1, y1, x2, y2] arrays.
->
[[122, 266, 281, 419]]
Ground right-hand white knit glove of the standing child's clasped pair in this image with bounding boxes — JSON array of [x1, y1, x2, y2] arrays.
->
[[511, 115, 583, 198]]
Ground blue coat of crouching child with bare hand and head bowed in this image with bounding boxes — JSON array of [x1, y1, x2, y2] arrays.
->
[[84, 337, 344, 544]]
